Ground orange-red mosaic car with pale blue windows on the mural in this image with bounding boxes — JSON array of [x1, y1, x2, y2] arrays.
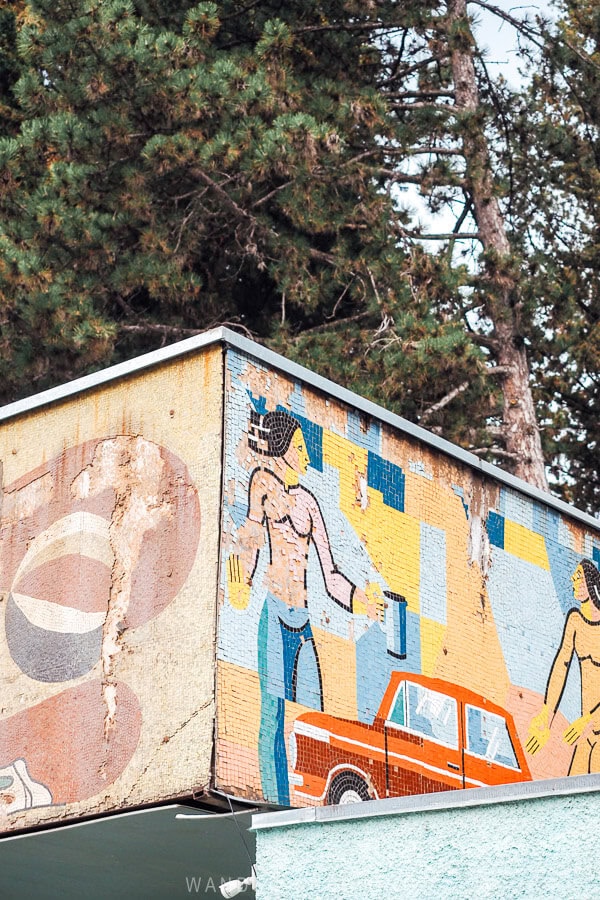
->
[[289, 672, 531, 805]]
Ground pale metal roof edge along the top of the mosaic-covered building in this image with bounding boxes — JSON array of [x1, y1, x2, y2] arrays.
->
[[0, 327, 600, 529]]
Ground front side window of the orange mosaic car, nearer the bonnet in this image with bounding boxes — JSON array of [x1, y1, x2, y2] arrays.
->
[[388, 681, 458, 749]]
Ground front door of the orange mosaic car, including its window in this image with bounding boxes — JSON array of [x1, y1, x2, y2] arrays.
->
[[385, 679, 464, 797]]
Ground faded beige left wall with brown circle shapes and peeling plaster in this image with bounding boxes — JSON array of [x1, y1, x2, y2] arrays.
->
[[0, 346, 222, 830]]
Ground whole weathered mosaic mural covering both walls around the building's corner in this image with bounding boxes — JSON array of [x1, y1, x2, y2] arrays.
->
[[0, 343, 600, 830]]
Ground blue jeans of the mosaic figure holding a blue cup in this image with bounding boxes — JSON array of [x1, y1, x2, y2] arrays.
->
[[258, 594, 323, 806]]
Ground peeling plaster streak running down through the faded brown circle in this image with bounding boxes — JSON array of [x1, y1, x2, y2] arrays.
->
[[71, 436, 173, 738]]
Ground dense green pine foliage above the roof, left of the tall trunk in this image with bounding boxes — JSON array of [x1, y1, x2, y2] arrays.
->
[[0, 0, 484, 436]]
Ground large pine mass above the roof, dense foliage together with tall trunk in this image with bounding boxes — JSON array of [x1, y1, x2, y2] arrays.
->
[[0, 0, 588, 500]]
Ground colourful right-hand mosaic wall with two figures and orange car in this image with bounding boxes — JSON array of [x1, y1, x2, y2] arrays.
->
[[216, 350, 600, 806]]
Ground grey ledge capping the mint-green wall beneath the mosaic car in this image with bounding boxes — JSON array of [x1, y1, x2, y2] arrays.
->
[[252, 775, 600, 831]]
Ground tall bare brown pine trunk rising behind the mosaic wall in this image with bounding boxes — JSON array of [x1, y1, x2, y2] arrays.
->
[[448, 0, 548, 491]]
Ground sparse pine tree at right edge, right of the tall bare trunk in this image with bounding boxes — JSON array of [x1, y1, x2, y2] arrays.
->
[[504, 0, 600, 511]]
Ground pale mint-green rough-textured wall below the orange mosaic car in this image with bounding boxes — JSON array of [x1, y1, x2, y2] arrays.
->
[[255, 787, 600, 900]]
